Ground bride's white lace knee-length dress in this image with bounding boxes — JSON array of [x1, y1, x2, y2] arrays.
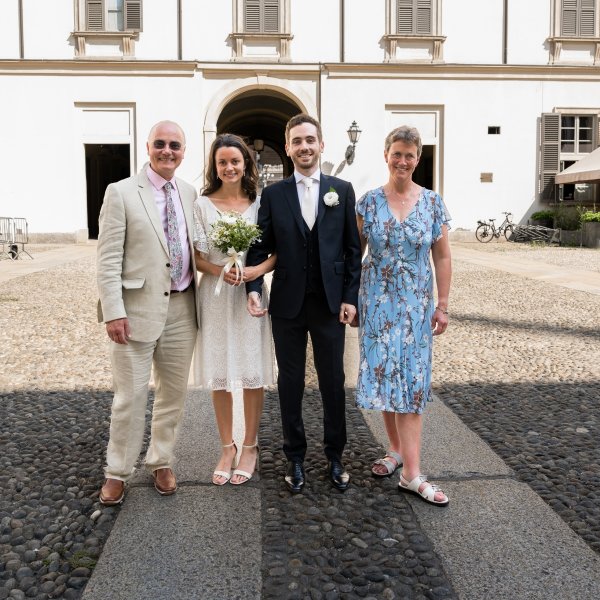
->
[[192, 196, 274, 391]]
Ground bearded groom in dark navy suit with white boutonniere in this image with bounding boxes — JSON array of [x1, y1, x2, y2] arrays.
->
[[246, 114, 361, 492]]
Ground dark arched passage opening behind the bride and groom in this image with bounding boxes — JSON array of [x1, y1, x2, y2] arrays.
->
[[217, 90, 302, 189]]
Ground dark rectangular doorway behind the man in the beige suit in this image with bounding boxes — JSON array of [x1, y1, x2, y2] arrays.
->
[[85, 144, 131, 240]]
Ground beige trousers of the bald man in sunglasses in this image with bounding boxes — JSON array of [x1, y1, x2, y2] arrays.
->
[[104, 290, 197, 481]]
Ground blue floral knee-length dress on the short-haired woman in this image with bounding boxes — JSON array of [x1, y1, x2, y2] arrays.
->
[[356, 187, 450, 414]]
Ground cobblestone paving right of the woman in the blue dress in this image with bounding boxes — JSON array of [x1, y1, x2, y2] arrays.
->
[[434, 243, 600, 552]]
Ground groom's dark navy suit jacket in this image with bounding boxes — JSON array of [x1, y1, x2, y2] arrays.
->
[[246, 174, 361, 319]]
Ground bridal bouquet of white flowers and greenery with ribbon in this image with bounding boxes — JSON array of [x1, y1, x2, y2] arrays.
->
[[210, 211, 260, 296]]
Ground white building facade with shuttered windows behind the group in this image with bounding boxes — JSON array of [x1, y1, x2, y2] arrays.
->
[[0, 0, 600, 240]]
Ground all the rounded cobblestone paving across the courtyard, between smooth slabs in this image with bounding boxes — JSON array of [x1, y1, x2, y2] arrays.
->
[[0, 244, 600, 600]]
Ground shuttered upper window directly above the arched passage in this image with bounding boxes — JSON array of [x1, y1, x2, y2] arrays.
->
[[229, 0, 293, 61]]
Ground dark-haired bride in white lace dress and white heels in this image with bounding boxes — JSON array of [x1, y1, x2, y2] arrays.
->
[[194, 134, 275, 485]]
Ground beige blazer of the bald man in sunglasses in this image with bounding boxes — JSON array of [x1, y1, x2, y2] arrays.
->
[[97, 170, 199, 342]]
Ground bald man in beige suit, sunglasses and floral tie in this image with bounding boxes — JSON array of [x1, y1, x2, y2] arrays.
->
[[97, 121, 198, 506]]
